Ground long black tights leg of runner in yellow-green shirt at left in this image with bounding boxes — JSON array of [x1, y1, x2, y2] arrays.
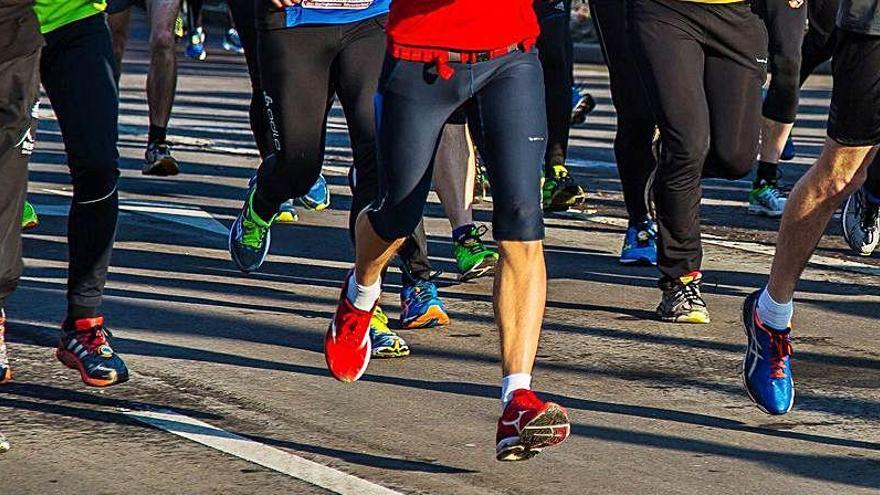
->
[[40, 14, 119, 316]]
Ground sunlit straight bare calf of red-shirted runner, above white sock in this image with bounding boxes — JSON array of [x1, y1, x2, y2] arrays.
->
[[493, 241, 547, 376]]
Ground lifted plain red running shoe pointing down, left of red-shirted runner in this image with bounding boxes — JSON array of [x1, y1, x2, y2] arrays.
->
[[324, 276, 375, 382]]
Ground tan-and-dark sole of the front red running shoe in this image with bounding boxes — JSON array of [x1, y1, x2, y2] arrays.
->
[[495, 403, 571, 462]]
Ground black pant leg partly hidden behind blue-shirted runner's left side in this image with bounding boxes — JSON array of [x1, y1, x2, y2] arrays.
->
[[228, 0, 272, 158]]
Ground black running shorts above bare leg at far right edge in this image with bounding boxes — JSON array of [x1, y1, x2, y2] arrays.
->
[[828, 29, 880, 146]]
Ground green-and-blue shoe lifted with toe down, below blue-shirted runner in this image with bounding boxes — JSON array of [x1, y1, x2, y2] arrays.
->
[[229, 186, 278, 273]]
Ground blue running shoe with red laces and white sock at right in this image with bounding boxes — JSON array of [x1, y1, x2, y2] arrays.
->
[[743, 291, 794, 415]]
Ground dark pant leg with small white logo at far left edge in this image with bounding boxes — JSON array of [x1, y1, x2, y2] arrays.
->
[[0, 49, 40, 310]]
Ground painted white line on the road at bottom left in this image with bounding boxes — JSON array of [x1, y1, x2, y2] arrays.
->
[[121, 410, 401, 495]]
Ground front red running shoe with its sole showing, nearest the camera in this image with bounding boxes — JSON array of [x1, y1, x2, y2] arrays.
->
[[495, 389, 571, 461]]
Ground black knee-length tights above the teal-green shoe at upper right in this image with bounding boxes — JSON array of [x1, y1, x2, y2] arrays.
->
[[752, 0, 807, 124]]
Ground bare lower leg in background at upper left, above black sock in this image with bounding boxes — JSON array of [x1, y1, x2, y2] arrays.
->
[[147, 0, 180, 128]]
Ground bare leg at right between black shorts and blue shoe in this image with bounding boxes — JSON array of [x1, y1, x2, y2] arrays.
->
[[767, 138, 877, 303]]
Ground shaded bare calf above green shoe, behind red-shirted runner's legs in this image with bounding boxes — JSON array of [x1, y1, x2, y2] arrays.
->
[[433, 124, 477, 230]]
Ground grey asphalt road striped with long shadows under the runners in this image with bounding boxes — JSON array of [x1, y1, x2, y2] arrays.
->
[[0, 10, 880, 495]]
